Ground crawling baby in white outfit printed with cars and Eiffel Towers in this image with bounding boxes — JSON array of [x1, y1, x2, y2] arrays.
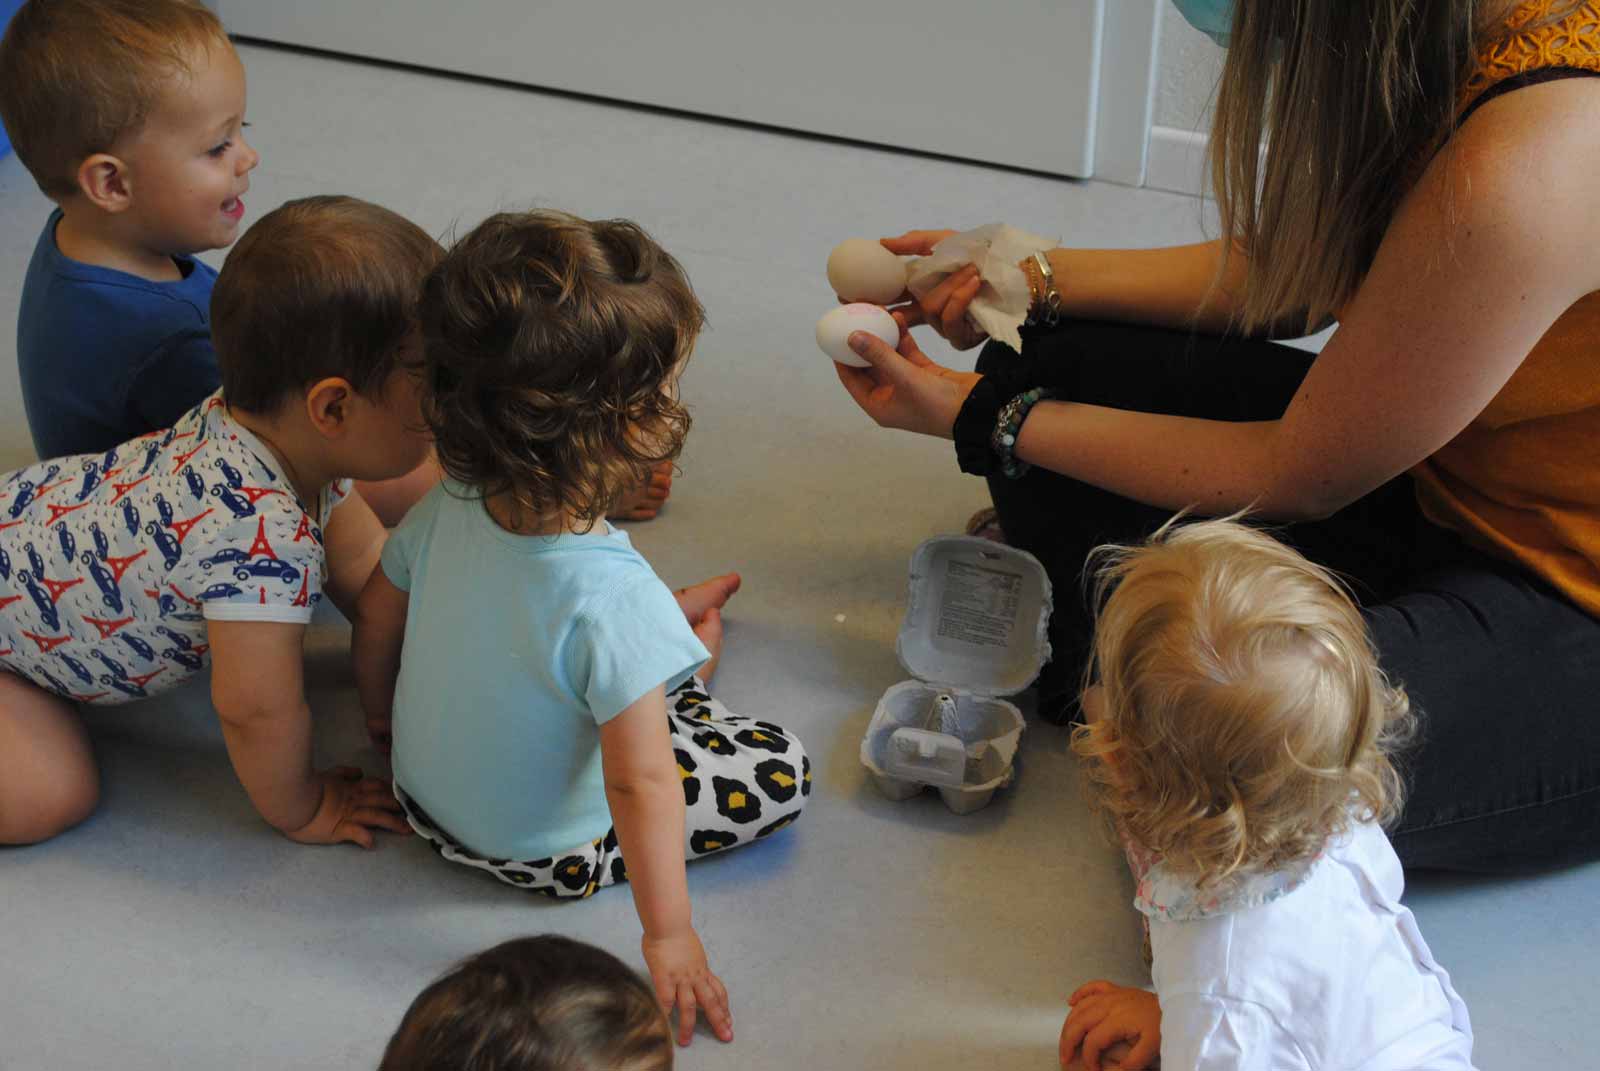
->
[[0, 197, 440, 845]]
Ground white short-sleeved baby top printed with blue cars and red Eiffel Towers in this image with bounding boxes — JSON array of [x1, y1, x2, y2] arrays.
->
[[0, 395, 347, 704]]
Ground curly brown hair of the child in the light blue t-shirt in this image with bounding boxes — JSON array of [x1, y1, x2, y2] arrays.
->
[[421, 211, 706, 528]]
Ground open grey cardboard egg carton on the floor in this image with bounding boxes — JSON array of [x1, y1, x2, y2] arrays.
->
[[861, 536, 1051, 813]]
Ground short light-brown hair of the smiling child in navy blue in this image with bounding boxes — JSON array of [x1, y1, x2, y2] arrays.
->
[[0, 0, 232, 202]]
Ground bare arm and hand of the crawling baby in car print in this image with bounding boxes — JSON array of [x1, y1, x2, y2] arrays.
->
[[208, 621, 410, 848]]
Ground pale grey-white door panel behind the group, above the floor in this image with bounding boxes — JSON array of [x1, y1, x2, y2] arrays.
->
[[214, 0, 1154, 181]]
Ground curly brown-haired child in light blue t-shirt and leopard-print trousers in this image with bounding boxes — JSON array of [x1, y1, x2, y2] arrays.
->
[[354, 213, 810, 1044]]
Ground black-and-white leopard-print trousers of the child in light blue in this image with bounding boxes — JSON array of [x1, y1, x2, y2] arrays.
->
[[395, 677, 811, 900]]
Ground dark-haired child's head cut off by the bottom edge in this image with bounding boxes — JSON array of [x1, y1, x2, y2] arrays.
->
[[379, 933, 672, 1071]]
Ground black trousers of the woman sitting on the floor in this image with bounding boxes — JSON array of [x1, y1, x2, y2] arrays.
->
[[978, 322, 1600, 872]]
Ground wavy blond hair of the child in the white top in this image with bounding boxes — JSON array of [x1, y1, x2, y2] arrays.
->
[[1072, 519, 1413, 887]]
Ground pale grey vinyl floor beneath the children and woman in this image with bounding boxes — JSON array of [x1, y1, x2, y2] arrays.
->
[[0, 45, 1600, 1071]]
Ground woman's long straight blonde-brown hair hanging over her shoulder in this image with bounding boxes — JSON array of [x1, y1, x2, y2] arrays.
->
[[1211, 0, 1582, 333]]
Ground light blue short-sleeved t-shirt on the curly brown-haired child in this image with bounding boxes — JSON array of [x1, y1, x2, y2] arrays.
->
[[382, 483, 709, 860]]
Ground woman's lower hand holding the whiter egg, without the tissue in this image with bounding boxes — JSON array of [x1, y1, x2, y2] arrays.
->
[[834, 309, 982, 439]]
